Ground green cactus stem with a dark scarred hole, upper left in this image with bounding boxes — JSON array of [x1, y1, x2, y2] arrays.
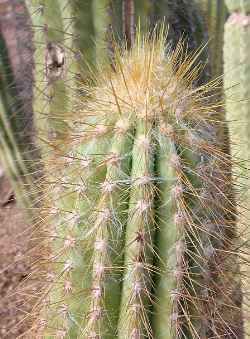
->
[[27, 0, 77, 152]]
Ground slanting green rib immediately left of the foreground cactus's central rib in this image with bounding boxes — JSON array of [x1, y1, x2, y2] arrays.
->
[[83, 121, 131, 338]]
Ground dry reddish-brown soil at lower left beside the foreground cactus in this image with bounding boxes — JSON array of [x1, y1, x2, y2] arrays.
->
[[0, 174, 30, 339]]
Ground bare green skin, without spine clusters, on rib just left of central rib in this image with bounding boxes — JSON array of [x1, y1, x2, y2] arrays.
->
[[82, 126, 132, 338]]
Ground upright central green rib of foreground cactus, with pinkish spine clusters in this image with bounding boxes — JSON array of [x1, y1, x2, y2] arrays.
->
[[118, 118, 155, 338]]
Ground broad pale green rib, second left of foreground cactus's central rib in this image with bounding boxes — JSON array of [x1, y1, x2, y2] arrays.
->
[[38, 117, 115, 338]]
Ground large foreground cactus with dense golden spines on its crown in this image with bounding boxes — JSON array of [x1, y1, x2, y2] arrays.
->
[[12, 22, 248, 339]]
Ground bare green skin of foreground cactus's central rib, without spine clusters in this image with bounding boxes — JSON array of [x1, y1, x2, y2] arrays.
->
[[118, 119, 155, 339]]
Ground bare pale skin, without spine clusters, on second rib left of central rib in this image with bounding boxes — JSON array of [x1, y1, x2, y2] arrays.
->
[[40, 126, 113, 338]]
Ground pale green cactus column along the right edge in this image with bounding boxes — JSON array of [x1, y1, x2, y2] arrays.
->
[[224, 1, 250, 336]]
